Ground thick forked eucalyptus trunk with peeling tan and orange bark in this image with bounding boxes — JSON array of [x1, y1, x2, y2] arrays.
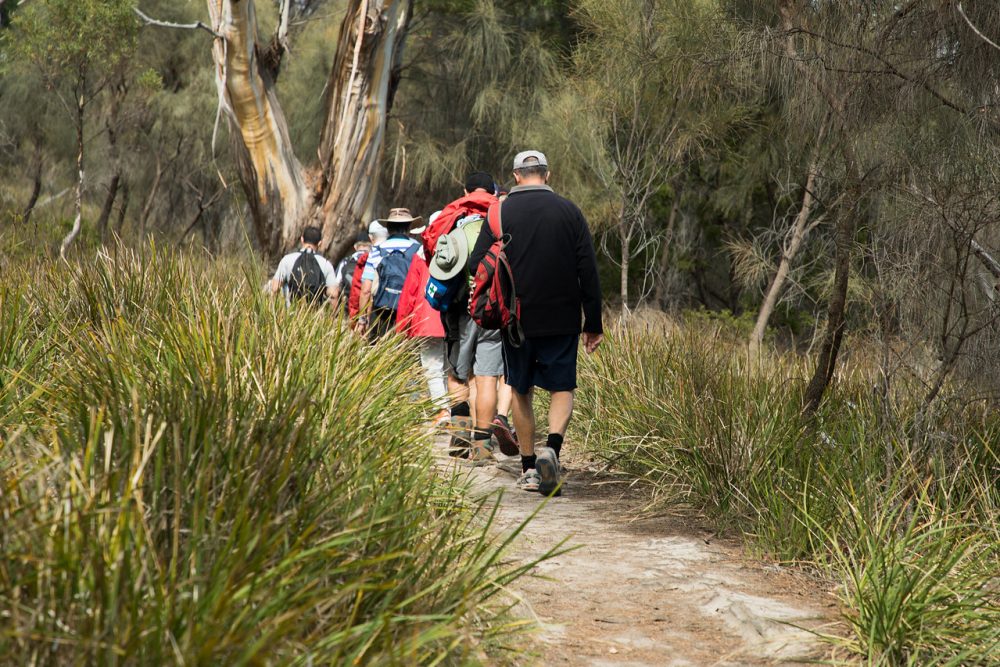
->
[[207, 0, 412, 256]]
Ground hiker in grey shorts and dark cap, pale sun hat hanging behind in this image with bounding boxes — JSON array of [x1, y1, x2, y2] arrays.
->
[[423, 171, 510, 465]]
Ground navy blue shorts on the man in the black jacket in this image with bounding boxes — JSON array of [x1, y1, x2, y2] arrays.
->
[[503, 334, 580, 394]]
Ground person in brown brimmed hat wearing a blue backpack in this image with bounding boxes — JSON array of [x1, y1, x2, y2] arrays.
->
[[358, 208, 421, 341]]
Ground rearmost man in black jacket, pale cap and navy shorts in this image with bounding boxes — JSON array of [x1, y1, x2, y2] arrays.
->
[[471, 151, 603, 495]]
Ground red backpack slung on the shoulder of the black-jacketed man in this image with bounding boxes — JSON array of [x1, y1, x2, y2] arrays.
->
[[469, 202, 524, 347]]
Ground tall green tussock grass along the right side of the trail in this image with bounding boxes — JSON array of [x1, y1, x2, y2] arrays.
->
[[577, 322, 1000, 665]]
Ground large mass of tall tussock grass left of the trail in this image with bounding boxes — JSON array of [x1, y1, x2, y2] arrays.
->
[[0, 249, 524, 665]]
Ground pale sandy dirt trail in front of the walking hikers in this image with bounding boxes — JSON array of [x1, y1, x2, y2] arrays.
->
[[445, 448, 835, 666]]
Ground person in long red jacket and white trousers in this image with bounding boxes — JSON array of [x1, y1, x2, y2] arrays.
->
[[396, 239, 450, 425]]
